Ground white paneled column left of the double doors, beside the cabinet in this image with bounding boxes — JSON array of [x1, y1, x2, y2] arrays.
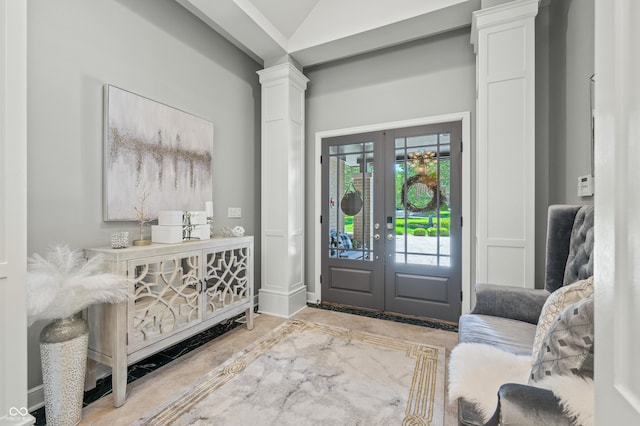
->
[[258, 63, 309, 317]]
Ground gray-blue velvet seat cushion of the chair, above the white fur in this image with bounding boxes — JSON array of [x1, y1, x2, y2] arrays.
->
[[458, 314, 536, 356]]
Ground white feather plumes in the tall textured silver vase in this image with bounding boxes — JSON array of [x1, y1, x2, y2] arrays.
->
[[27, 244, 131, 325]]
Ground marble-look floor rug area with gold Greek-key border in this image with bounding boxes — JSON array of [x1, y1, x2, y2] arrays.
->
[[135, 320, 445, 425]]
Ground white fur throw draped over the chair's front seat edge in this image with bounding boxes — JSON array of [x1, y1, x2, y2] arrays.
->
[[449, 343, 531, 422]]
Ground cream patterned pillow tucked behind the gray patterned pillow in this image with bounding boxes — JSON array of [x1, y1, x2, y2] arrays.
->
[[531, 277, 593, 362]]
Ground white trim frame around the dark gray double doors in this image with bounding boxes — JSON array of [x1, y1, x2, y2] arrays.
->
[[307, 111, 473, 314]]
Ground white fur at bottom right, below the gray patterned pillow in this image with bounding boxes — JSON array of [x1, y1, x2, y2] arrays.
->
[[536, 376, 595, 426]]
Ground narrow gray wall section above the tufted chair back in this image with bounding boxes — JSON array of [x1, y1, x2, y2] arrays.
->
[[549, 0, 597, 204]]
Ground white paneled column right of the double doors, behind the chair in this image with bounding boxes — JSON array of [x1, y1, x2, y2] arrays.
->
[[471, 0, 538, 288]]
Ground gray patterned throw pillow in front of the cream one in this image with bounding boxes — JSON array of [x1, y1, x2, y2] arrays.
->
[[529, 296, 594, 383]]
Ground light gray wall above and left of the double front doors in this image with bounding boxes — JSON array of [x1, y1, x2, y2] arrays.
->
[[304, 28, 475, 291]]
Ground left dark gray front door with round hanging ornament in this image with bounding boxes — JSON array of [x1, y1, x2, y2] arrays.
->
[[322, 133, 384, 310]]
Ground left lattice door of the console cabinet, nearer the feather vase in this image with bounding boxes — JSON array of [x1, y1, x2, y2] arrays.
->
[[127, 251, 202, 353]]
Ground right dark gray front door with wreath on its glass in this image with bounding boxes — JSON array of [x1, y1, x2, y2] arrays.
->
[[385, 122, 462, 321]]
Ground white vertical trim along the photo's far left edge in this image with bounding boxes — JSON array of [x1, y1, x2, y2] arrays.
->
[[0, 0, 35, 425]]
